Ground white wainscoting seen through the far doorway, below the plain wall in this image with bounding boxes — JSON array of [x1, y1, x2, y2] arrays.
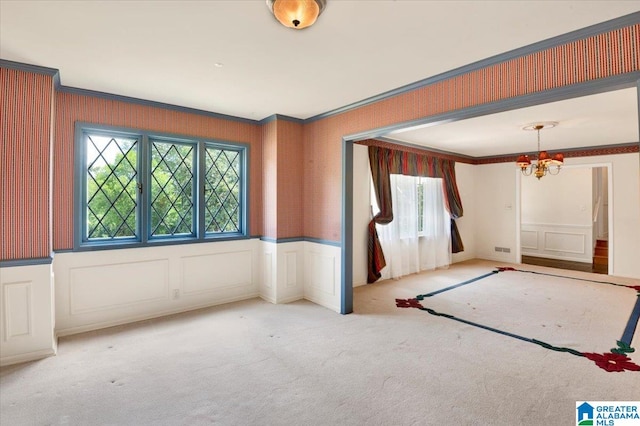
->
[[520, 223, 593, 263]]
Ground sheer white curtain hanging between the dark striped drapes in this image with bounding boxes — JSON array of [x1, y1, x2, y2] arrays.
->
[[372, 174, 451, 279]]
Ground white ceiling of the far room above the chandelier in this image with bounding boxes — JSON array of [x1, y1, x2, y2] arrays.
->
[[388, 88, 639, 157]]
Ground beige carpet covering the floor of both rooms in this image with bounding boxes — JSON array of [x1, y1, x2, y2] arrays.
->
[[0, 261, 640, 426]]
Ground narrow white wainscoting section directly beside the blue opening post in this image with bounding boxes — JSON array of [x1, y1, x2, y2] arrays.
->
[[304, 241, 342, 312]]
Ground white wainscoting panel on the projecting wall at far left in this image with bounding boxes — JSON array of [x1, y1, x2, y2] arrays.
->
[[0, 265, 56, 365]]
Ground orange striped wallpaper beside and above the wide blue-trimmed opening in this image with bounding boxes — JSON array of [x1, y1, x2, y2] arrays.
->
[[304, 24, 640, 241]]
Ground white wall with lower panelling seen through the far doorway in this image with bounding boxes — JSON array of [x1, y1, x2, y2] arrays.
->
[[520, 165, 593, 263]]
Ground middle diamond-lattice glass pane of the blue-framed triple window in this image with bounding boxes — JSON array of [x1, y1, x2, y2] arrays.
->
[[150, 141, 195, 237]]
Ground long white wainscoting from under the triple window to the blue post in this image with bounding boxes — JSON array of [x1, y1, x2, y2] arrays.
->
[[54, 239, 341, 335]]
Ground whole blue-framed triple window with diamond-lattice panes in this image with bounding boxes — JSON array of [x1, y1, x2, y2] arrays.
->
[[76, 127, 247, 246]]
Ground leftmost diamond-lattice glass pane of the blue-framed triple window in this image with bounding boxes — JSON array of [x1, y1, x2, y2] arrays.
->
[[84, 134, 138, 240]]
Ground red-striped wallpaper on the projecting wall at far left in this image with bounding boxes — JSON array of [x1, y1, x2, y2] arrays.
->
[[0, 68, 54, 260]]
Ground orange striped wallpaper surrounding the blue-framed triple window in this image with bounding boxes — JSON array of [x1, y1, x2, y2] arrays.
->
[[53, 92, 262, 250]]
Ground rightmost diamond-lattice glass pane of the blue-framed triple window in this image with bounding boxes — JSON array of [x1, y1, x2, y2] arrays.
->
[[204, 147, 242, 233]]
